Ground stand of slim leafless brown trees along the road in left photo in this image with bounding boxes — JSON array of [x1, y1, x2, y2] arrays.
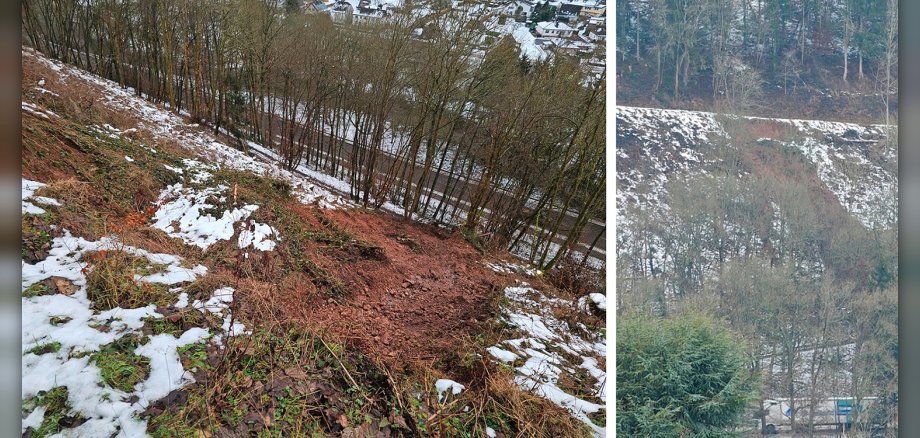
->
[[22, 0, 606, 268]]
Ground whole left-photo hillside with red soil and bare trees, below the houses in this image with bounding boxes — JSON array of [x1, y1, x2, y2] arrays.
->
[[21, 0, 607, 438]]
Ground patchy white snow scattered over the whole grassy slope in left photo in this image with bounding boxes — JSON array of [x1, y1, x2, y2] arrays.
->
[[21, 48, 606, 436]]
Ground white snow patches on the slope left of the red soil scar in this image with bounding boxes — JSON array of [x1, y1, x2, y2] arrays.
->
[[21, 48, 350, 436]]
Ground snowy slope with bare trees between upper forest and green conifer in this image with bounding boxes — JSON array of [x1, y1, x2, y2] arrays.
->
[[616, 106, 898, 432]]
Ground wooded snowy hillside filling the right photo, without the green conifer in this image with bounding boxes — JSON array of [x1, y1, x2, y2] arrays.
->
[[615, 0, 898, 436]]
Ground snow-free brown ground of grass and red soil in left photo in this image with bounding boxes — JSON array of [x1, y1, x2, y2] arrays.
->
[[22, 46, 587, 436]]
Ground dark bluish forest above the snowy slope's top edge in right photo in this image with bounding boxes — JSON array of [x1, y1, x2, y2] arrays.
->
[[616, 0, 898, 124]]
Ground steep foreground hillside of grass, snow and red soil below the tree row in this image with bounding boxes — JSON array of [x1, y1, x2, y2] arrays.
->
[[21, 48, 606, 436]]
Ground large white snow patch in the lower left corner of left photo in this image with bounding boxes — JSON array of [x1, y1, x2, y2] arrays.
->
[[21, 178, 243, 436]]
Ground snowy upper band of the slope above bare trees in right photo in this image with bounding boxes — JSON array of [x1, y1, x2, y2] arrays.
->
[[616, 106, 898, 228]]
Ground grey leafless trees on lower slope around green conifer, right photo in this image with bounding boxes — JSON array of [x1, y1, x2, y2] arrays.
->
[[616, 164, 898, 434]]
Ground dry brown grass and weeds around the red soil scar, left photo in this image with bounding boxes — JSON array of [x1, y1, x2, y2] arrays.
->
[[23, 54, 604, 437]]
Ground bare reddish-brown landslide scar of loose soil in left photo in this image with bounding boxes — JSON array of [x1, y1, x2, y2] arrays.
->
[[288, 206, 507, 362]]
